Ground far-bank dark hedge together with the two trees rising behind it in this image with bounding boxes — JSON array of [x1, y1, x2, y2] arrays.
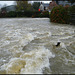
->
[[0, 1, 45, 18]]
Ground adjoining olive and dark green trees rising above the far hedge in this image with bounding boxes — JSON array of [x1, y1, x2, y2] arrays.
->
[[16, 1, 40, 11]]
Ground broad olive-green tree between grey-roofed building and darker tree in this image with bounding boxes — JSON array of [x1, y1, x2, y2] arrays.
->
[[16, 1, 31, 11]]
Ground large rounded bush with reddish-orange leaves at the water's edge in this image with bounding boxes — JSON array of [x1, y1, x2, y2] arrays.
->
[[50, 6, 70, 24]]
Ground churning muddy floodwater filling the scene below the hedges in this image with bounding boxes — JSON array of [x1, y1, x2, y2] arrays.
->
[[0, 18, 75, 74]]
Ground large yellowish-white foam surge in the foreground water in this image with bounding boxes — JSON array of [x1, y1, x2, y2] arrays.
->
[[2, 47, 54, 74]]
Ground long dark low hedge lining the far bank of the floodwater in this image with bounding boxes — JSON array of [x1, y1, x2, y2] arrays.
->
[[0, 11, 49, 18]]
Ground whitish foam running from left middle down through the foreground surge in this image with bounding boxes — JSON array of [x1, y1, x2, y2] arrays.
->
[[0, 28, 54, 74]]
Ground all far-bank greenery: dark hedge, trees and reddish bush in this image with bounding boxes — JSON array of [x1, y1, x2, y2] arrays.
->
[[0, 1, 75, 24]]
